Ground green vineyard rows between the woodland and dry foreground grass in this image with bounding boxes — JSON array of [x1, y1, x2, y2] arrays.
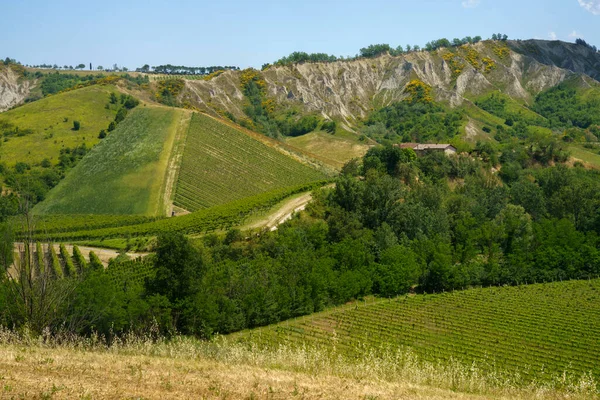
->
[[233, 279, 600, 383]]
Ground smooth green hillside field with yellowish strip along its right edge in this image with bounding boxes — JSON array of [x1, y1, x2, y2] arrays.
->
[[34, 107, 186, 216]]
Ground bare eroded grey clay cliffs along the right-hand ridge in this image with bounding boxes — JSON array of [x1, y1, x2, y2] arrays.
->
[[183, 41, 600, 129]]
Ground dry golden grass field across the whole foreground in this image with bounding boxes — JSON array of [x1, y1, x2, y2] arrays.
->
[[0, 331, 595, 399]]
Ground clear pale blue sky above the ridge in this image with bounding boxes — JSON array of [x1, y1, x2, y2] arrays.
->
[[0, 0, 600, 68]]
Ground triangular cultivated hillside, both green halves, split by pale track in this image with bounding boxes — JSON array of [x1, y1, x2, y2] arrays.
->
[[34, 106, 326, 220]]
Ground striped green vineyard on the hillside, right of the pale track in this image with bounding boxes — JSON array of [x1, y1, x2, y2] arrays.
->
[[174, 114, 324, 211]]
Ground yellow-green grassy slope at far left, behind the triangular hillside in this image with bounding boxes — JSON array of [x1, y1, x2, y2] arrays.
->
[[0, 85, 118, 165]]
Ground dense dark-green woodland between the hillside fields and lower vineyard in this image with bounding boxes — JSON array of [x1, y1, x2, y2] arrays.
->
[[0, 134, 600, 337]]
